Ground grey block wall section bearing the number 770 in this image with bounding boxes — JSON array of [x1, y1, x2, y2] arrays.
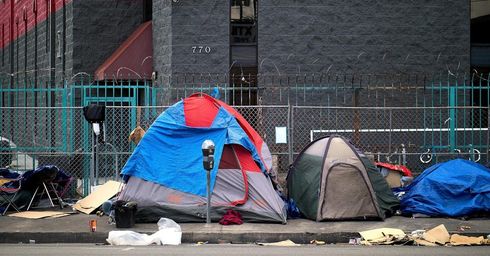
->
[[153, 0, 230, 80]]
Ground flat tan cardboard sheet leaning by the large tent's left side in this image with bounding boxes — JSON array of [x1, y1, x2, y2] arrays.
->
[[73, 180, 122, 214]]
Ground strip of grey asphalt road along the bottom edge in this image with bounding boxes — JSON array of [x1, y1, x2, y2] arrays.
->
[[0, 244, 490, 256]]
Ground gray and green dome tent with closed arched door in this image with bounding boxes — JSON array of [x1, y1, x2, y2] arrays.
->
[[287, 135, 399, 221]]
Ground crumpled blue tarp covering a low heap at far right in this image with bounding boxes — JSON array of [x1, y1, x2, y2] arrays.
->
[[400, 159, 490, 217]]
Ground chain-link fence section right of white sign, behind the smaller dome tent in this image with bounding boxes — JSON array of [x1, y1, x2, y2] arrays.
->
[[291, 107, 489, 173]]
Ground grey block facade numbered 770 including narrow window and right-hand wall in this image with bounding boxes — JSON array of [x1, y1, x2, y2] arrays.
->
[[153, 0, 470, 75]]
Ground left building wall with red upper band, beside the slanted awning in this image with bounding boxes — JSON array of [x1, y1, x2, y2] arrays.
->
[[0, 0, 146, 92]]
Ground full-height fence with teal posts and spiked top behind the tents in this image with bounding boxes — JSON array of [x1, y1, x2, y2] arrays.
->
[[0, 72, 490, 196]]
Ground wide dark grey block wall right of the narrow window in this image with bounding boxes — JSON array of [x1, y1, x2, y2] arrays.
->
[[259, 0, 470, 74]]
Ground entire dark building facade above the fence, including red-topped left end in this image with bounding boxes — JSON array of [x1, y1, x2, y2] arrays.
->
[[0, 0, 470, 91]]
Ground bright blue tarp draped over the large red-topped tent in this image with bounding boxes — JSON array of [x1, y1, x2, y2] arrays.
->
[[121, 101, 265, 196]]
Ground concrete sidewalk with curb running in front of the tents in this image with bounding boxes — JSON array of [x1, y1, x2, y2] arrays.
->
[[0, 210, 490, 243]]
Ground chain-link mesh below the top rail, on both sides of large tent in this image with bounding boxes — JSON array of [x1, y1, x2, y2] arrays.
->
[[0, 105, 490, 196]]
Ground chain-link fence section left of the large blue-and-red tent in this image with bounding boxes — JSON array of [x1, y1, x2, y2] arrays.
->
[[0, 107, 166, 196]]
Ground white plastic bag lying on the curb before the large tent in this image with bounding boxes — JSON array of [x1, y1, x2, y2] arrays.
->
[[106, 218, 182, 245]]
